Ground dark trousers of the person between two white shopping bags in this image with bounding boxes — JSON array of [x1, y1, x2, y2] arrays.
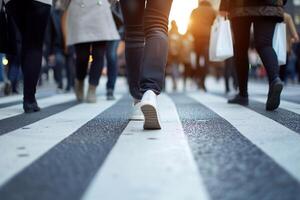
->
[[232, 17, 279, 96]]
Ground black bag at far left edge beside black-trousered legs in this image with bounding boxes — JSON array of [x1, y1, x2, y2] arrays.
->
[[0, 1, 18, 55]]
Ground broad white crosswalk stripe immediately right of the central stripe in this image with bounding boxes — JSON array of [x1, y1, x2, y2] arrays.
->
[[189, 93, 300, 181]]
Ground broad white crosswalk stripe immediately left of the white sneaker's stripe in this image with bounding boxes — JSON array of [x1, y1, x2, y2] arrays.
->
[[0, 96, 120, 185]]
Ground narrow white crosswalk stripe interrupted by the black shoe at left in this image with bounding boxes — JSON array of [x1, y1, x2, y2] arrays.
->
[[0, 94, 75, 120]]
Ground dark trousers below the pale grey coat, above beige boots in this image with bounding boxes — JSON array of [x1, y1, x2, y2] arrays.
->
[[75, 41, 106, 86]]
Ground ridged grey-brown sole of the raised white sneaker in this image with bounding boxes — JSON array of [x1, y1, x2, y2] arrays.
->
[[141, 105, 161, 130]]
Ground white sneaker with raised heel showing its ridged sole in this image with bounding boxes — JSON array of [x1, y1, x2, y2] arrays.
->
[[141, 90, 161, 130]]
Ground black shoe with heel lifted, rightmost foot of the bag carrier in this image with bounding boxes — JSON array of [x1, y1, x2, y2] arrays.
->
[[266, 78, 283, 111]]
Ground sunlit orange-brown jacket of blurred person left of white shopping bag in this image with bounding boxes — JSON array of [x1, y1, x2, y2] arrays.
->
[[189, 1, 217, 42]]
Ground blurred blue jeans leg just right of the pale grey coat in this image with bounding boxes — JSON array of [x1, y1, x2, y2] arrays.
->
[[106, 40, 120, 90]]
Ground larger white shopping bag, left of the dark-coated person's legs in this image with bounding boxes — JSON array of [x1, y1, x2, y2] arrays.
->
[[209, 17, 234, 62]]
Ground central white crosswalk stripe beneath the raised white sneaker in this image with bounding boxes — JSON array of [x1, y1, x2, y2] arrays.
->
[[83, 95, 209, 200]]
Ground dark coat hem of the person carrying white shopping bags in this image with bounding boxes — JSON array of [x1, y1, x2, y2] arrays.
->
[[220, 0, 287, 19]]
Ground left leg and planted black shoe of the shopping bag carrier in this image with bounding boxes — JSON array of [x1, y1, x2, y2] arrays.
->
[[228, 17, 252, 105]]
